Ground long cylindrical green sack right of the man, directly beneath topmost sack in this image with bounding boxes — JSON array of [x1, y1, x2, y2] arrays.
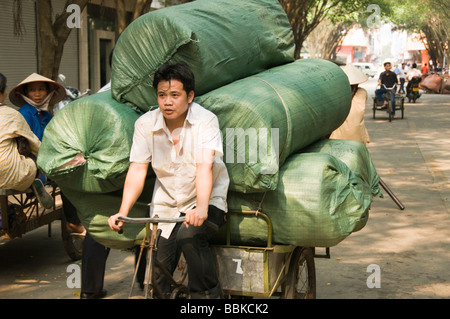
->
[[196, 59, 352, 193]]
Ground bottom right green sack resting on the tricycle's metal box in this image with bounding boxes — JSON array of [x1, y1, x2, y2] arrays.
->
[[214, 153, 373, 247]]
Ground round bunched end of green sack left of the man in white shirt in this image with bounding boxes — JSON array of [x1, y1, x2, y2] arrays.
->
[[37, 91, 139, 193]]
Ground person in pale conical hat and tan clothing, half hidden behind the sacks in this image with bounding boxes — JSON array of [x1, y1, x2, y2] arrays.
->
[[330, 64, 370, 145]]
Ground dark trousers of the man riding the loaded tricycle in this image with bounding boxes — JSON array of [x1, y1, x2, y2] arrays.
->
[[156, 205, 225, 299]]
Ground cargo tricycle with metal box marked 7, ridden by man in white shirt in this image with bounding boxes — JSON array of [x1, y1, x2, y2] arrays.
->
[[120, 211, 329, 299]]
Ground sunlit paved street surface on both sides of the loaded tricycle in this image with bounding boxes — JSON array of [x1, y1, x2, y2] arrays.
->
[[0, 79, 450, 299]]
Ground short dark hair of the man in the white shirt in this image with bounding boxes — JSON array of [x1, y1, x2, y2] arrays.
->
[[153, 62, 195, 93]]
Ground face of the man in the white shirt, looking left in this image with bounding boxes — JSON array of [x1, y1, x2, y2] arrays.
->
[[157, 80, 194, 123]]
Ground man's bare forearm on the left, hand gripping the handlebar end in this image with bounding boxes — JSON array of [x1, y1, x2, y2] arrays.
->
[[108, 162, 149, 231]]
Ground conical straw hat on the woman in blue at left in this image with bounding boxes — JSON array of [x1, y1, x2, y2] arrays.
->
[[9, 73, 66, 107]]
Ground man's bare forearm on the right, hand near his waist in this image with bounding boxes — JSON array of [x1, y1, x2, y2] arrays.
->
[[185, 149, 215, 227]]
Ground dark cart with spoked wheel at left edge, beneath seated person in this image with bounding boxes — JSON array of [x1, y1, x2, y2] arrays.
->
[[0, 182, 84, 260]]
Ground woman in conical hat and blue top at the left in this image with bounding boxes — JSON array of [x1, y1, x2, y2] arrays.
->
[[9, 73, 66, 140]]
